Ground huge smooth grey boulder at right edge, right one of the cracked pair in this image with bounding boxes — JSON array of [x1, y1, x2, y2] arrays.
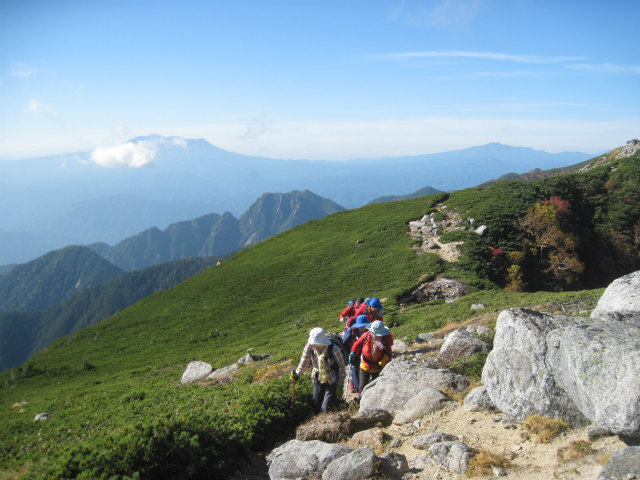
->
[[547, 320, 640, 437]]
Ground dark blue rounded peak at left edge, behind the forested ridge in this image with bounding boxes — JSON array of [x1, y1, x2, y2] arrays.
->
[[0, 246, 122, 312]]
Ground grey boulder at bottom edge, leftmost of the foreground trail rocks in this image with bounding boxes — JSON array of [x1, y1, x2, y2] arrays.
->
[[266, 440, 353, 480]]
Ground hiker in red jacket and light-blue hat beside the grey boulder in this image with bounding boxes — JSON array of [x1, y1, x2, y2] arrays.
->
[[349, 320, 393, 398]]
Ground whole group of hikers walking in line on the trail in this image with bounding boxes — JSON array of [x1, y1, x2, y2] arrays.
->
[[291, 297, 393, 413]]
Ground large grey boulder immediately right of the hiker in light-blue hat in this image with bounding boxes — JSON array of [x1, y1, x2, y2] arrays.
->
[[360, 358, 469, 414]]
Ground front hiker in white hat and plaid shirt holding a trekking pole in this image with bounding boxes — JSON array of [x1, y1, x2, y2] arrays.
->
[[291, 327, 345, 413]]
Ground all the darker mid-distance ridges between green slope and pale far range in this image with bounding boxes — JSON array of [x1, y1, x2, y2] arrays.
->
[[0, 191, 343, 371]]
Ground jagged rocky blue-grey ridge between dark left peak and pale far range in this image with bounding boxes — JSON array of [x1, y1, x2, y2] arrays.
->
[[90, 191, 343, 270]]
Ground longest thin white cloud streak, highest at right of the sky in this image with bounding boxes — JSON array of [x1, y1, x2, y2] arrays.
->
[[372, 50, 586, 64]]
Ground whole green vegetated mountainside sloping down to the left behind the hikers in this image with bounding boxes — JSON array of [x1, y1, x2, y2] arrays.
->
[[0, 149, 640, 478]]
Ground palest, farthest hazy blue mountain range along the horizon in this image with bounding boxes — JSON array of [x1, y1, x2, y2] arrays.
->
[[0, 135, 590, 265]]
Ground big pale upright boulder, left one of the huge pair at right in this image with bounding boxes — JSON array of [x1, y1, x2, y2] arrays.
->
[[482, 308, 589, 426]]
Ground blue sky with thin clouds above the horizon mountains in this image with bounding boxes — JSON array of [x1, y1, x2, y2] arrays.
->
[[0, 0, 640, 160]]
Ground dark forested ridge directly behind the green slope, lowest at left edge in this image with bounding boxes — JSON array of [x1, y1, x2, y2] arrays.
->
[[0, 257, 222, 371]]
